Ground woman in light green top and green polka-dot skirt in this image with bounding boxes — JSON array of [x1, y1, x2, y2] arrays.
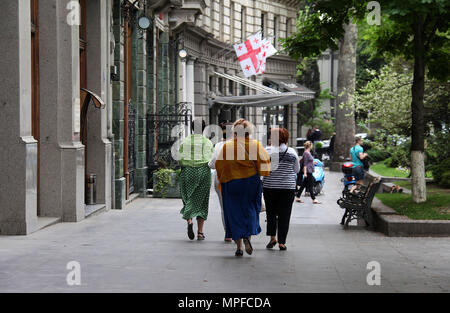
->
[[179, 120, 214, 240]]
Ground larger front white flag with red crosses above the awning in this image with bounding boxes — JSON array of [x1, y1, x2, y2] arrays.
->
[[234, 33, 262, 77]]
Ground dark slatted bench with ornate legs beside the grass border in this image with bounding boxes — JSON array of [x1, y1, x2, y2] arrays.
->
[[337, 178, 381, 228]]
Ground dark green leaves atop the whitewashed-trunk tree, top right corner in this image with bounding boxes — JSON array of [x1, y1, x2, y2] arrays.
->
[[363, 0, 450, 81]]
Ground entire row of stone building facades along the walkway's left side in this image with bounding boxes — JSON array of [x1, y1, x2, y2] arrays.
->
[[0, 0, 308, 235]]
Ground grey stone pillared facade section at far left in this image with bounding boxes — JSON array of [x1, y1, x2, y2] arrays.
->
[[0, 0, 116, 235]]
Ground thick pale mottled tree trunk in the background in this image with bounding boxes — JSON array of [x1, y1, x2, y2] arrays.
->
[[333, 23, 358, 165]]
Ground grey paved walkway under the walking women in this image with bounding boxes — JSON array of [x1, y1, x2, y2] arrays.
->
[[0, 169, 450, 293]]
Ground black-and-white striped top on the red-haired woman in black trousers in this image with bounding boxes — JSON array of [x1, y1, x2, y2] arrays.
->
[[263, 144, 300, 190]]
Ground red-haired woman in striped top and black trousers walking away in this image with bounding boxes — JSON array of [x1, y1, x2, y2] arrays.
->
[[263, 128, 300, 251]]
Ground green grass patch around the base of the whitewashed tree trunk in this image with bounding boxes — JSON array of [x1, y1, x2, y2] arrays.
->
[[376, 181, 450, 220]]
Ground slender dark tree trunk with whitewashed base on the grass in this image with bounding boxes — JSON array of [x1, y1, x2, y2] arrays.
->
[[411, 15, 427, 203]]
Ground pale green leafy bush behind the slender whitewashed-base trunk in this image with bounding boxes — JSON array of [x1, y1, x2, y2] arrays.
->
[[354, 59, 450, 137]]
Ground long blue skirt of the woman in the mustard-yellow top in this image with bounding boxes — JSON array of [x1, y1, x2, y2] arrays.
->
[[222, 175, 262, 240]]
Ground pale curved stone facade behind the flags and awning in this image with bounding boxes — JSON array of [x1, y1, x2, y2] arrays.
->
[[169, 0, 300, 144]]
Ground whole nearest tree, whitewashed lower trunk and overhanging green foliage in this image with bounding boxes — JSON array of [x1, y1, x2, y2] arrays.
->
[[284, 0, 450, 202]]
